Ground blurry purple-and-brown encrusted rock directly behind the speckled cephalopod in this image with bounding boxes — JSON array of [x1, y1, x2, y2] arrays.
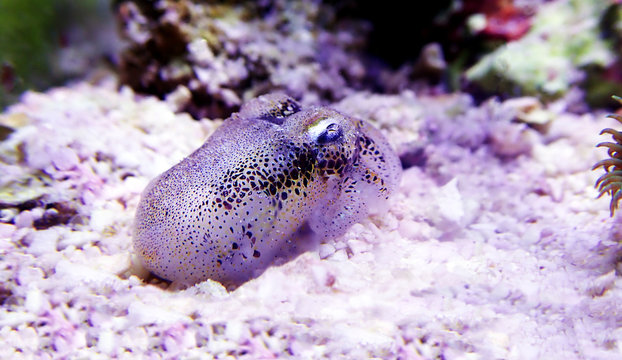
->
[[116, 0, 366, 118]]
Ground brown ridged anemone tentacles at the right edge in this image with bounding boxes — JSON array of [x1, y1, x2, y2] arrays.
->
[[592, 96, 622, 216]]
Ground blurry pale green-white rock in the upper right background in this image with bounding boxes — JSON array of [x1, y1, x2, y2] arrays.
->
[[466, 0, 614, 97]]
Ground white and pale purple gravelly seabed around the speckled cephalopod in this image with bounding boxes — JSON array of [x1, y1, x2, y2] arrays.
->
[[0, 79, 622, 359]]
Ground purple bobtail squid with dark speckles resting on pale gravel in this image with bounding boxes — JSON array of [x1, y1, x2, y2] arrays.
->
[[134, 94, 401, 285]]
